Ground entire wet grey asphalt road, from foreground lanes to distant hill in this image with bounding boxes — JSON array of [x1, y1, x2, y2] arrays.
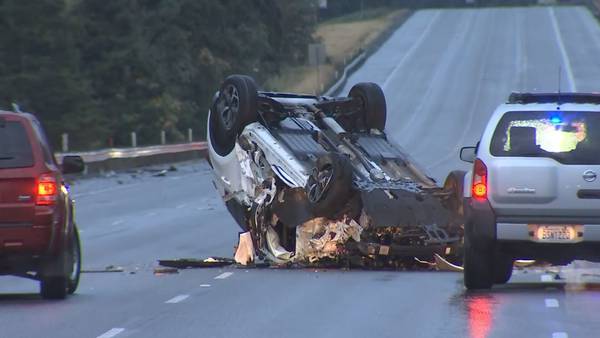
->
[[0, 8, 600, 338]]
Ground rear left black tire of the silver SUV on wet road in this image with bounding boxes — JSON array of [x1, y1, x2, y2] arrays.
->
[[463, 233, 494, 290]]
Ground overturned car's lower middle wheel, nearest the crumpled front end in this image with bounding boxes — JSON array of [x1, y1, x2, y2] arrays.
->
[[306, 153, 352, 218]]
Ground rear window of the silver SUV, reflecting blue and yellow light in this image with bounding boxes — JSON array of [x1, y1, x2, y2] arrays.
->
[[490, 111, 600, 164]]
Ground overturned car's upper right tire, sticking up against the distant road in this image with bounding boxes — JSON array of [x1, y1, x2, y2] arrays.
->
[[348, 82, 387, 131]]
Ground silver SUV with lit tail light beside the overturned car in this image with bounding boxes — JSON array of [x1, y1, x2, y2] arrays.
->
[[460, 93, 600, 289]]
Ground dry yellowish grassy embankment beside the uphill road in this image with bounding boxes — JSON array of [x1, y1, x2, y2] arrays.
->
[[264, 8, 406, 94]]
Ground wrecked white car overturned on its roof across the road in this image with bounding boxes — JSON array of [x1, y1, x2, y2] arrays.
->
[[207, 75, 464, 266]]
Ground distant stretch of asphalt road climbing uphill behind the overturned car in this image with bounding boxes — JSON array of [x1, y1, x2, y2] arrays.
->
[[342, 7, 600, 182]]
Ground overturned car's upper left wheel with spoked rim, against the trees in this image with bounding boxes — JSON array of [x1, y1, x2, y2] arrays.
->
[[209, 75, 258, 156]]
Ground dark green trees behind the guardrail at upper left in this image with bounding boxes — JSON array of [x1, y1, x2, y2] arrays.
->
[[0, 0, 318, 149]]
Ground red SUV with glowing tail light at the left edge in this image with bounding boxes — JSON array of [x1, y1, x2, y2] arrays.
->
[[0, 111, 84, 299]]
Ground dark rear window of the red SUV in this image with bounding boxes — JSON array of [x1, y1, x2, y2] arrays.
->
[[0, 118, 33, 169]]
